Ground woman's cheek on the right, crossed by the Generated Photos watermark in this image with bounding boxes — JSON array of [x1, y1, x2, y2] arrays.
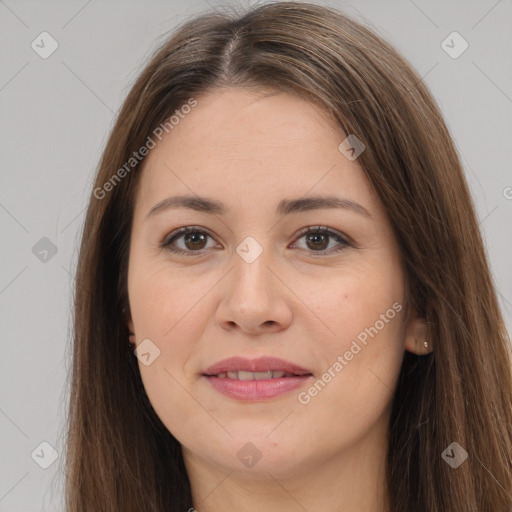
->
[[292, 258, 404, 414]]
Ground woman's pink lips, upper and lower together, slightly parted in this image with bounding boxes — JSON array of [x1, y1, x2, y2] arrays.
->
[[202, 357, 313, 402]]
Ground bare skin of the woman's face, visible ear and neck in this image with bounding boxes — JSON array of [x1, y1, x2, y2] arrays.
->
[[128, 88, 430, 512]]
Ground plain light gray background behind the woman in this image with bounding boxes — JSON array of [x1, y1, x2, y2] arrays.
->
[[0, 0, 512, 512]]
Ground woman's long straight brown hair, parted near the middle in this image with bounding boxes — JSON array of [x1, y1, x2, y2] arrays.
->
[[66, 2, 512, 512]]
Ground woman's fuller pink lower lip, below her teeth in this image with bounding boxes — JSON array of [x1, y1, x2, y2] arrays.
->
[[205, 375, 312, 401]]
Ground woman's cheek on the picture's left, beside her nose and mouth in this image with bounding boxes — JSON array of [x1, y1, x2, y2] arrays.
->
[[129, 265, 211, 442]]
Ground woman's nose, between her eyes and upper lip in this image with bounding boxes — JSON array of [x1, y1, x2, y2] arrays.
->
[[215, 244, 293, 335]]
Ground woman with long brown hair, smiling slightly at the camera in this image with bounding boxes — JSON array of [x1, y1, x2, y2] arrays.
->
[[66, 2, 512, 512]]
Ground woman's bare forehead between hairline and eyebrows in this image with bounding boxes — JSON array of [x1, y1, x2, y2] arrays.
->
[[137, 88, 375, 218]]
